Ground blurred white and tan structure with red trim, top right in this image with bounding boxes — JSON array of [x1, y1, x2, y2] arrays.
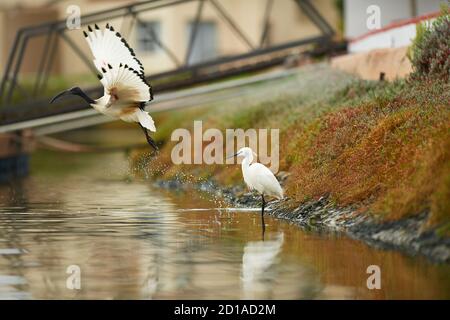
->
[[331, 0, 448, 80]]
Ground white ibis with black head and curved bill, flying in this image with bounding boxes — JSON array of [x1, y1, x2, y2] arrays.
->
[[51, 24, 158, 150]]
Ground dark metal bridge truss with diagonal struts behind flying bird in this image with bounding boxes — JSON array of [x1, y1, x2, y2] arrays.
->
[[0, 0, 334, 124]]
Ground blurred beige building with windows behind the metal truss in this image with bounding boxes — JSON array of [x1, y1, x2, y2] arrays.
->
[[0, 0, 340, 75]]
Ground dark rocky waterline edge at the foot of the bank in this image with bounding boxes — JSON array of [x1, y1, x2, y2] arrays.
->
[[154, 179, 450, 264]]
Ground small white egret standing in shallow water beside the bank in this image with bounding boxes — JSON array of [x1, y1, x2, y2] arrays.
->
[[231, 147, 283, 236]]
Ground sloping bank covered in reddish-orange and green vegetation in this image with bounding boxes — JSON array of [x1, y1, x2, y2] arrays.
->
[[136, 65, 450, 235]]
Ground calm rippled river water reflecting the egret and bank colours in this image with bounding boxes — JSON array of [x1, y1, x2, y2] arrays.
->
[[0, 141, 450, 299]]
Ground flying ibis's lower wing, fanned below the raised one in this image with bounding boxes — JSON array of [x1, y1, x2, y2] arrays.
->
[[100, 64, 153, 105]]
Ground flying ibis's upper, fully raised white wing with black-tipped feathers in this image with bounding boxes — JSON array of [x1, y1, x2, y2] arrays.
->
[[84, 24, 144, 74]]
